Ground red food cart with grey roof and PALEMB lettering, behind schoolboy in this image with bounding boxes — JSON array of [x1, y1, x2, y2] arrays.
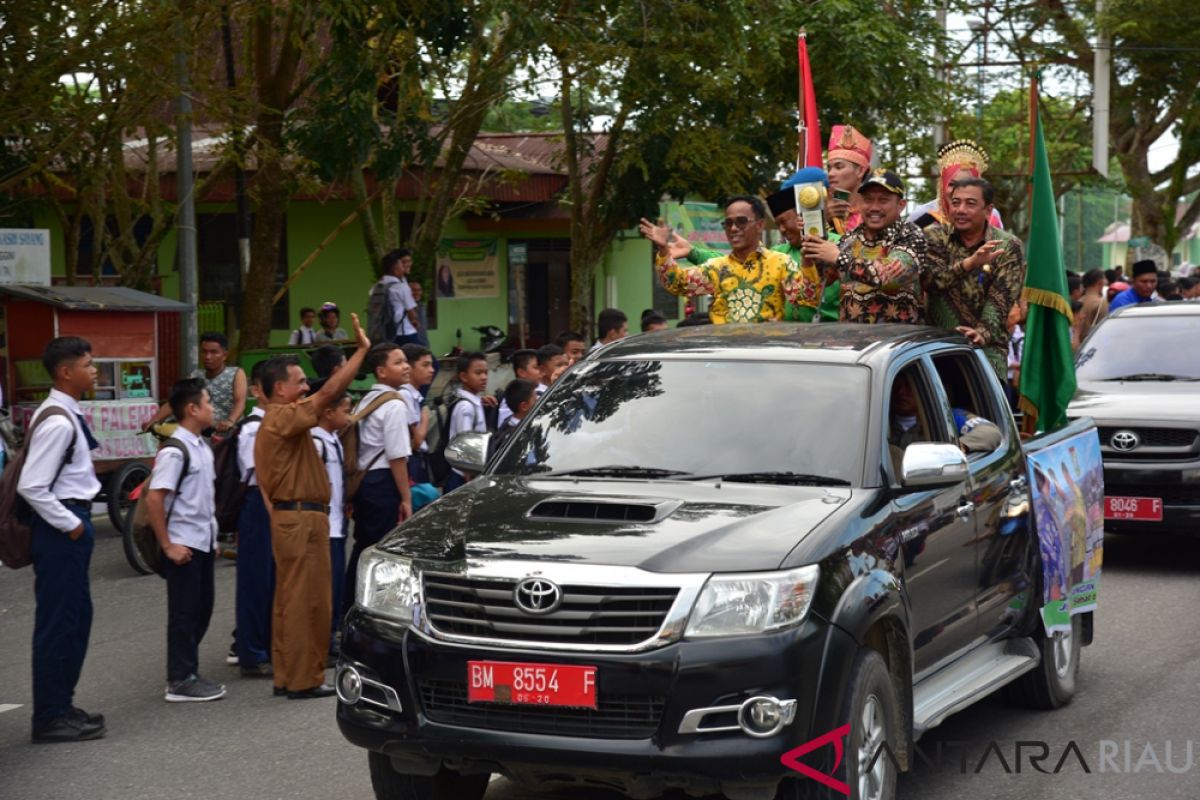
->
[[0, 285, 187, 530]]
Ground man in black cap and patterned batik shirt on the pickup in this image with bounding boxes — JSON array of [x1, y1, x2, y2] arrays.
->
[[804, 169, 928, 325]]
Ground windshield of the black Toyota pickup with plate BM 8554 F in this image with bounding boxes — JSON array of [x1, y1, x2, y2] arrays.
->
[[492, 360, 869, 486]]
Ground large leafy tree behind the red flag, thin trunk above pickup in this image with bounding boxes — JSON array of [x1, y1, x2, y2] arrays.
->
[[542, 0, 940, 330]]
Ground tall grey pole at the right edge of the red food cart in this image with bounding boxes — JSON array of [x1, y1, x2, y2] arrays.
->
[[175, 14, 199, 375]]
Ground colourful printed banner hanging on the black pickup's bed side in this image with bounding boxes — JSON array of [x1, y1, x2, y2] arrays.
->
[[1028, 429, 1104, 633]]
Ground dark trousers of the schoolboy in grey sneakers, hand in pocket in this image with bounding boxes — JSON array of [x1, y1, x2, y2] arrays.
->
[[164, 549, 214, 684]]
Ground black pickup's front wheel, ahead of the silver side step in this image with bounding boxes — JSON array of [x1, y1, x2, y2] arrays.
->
[[775, 649, 902, 800]]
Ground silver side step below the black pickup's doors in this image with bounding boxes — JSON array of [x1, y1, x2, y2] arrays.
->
[[912, 638, 1042, 739]]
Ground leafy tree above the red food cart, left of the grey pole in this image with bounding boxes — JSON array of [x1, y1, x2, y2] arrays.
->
[[0, 0, 182, 289]]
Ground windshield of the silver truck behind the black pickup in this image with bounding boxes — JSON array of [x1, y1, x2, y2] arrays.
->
[[1075, 314, 1200, 383]]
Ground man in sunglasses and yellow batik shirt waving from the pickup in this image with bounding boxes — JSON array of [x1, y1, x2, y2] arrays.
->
[[642, 196, 820, 325]]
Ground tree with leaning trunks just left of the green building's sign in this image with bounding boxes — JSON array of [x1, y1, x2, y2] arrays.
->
[[294, 0, 532, 286]]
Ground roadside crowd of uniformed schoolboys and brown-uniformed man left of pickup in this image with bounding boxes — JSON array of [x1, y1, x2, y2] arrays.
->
[[4, 266, 614, 742]]
